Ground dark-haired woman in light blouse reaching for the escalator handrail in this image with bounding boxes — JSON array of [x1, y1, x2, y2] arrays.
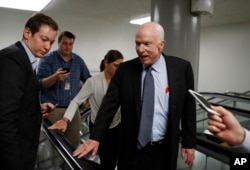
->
[[49, 50, 123, 170]]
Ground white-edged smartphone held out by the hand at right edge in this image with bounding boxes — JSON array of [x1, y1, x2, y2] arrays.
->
[[188, 89, 221, 116]]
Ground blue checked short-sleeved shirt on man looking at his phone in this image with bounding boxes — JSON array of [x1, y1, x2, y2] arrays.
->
[[37, 51, 91, 107]]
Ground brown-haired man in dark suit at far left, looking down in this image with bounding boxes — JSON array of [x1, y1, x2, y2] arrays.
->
[[0, 13, 58, 170]]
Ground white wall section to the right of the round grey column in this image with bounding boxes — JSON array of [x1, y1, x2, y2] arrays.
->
[[198, 22, 250, 92]]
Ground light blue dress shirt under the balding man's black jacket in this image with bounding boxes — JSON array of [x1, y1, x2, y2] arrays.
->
[[141, 55, 169, 141]]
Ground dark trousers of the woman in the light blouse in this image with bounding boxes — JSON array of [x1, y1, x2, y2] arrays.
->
[[89, 122, 120, 170]]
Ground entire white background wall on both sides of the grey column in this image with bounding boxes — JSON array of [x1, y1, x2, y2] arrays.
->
[[0, 8, 250, 92]]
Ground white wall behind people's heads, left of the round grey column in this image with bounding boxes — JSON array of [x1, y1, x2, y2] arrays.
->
[[0, 8, 138, 71]]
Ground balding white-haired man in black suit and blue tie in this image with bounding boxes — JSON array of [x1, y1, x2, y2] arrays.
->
[[73, 22, 196, 170]]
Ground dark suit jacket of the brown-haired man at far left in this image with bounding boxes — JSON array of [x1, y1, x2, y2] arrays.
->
[[0, 42, 41, 170]]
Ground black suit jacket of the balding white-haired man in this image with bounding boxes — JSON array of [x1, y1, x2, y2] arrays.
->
[[90, 55, 196, 170]]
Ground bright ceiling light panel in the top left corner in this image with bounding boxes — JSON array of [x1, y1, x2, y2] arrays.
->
[[0, 0, 51, 11]]
